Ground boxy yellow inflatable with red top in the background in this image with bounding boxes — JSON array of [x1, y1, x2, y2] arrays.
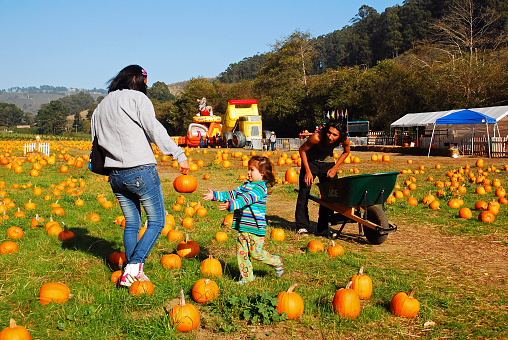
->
[[222, 99, 270, 149]]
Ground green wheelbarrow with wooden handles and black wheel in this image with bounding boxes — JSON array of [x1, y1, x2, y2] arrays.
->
[[296, 172, 399, 244]]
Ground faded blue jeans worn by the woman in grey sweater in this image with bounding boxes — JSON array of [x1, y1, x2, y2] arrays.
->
[[109, 165, 166, 263]]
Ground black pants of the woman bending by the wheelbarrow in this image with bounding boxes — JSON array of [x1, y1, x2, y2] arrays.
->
[[295, 161, 337, 233]]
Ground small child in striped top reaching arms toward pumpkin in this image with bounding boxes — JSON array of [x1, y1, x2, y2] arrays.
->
[[203, 156, 284, 285]]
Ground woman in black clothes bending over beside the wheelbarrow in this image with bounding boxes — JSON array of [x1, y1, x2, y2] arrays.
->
[[295, 120, 351, 236]]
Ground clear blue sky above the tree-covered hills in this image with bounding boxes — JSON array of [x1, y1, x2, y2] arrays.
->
[[0, 0, 402, 89]]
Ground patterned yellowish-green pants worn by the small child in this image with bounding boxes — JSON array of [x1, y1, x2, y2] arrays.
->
[[236, 232, 282, 281]]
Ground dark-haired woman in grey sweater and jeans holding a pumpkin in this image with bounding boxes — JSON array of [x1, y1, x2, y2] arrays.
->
[[91, 65, 189, 287]]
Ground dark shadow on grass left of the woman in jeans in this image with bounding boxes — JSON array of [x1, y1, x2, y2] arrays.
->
[[62, 228, 118, 269]]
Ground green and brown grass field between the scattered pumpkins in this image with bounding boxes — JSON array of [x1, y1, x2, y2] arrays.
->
[[0, 141, 508, 339]]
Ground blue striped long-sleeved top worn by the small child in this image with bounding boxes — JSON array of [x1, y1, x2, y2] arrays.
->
[[213, 181, 267, 236]]
